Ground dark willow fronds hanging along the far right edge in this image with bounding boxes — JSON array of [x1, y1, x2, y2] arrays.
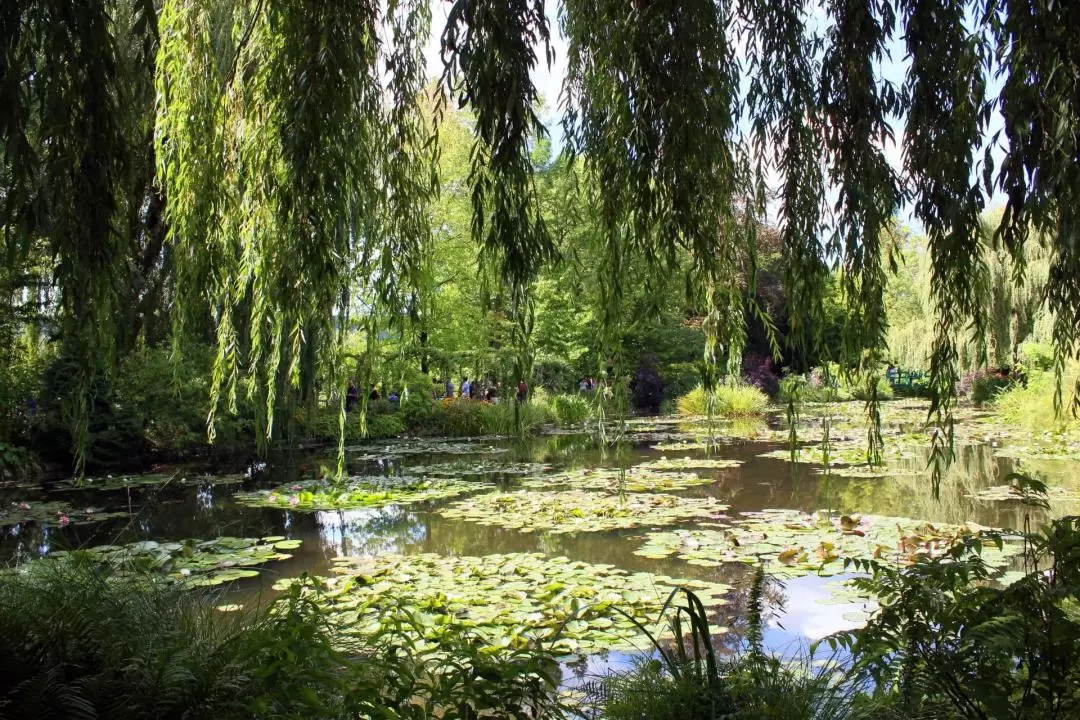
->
[[982, 0, 1080, 413]]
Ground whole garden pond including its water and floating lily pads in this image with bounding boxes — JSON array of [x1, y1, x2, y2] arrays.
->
[[0, 410, 1080, 671]]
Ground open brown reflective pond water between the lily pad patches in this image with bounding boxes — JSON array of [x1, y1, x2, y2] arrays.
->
[[0, 414, 1077, 668]]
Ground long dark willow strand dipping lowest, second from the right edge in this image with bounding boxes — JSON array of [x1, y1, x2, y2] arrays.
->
[[903, 0, 988, 492]]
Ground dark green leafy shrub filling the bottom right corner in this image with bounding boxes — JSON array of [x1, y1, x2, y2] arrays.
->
[[832, 500, 1080, 718]]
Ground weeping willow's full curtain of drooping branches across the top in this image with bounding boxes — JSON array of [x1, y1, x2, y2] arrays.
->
[[0, 0, 1080, 496]]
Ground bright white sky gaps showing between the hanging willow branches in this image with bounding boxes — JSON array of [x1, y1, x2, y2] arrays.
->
[[426, 0, 1003, 232]]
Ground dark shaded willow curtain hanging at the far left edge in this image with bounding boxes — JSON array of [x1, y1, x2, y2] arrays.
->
[[0, 0, 137, 472]]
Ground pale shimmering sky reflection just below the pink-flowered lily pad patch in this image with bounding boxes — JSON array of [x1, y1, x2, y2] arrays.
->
[[315, 505, 428, 557]]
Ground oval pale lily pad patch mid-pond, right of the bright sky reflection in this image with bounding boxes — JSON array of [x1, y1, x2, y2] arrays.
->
[[437, 490, 727, 534]]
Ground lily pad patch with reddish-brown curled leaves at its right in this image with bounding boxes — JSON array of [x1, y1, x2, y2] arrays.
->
[[635, 510, 1020, 578]]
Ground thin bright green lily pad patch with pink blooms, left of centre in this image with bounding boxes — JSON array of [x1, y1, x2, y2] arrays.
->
[[233, 475, 491, 511]]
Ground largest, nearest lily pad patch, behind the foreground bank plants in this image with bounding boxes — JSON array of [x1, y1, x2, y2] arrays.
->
[[279, 553, 731, 654]]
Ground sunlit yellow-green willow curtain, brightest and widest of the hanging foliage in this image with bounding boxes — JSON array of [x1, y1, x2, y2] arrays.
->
[[158, 0, 432, 451]]
